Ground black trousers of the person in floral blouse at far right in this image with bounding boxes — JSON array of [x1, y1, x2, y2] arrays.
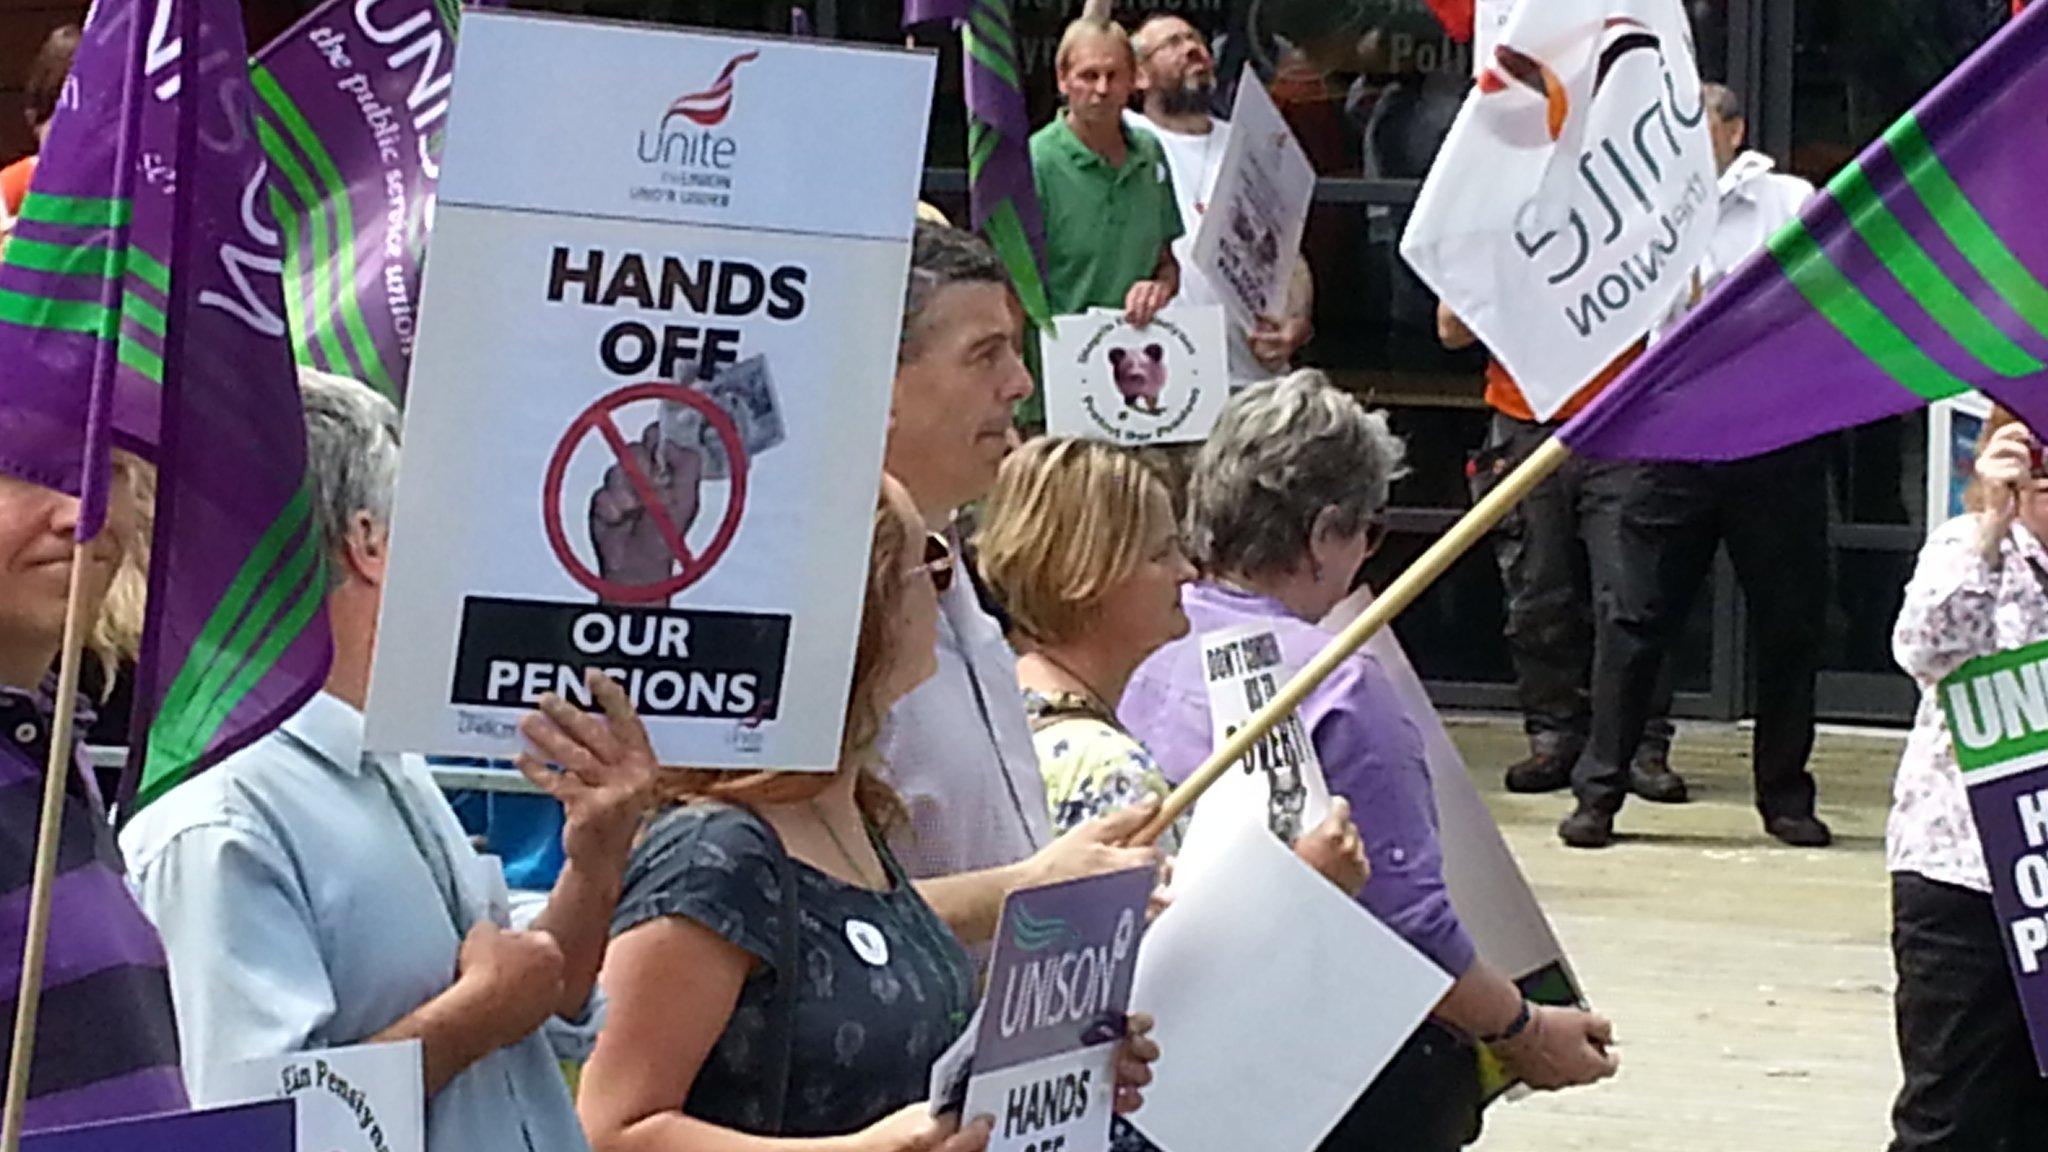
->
[[1890, 873, 2048, 1152]]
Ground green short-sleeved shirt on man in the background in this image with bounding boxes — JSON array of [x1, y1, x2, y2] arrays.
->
[[1030, 115, 1182, 316]]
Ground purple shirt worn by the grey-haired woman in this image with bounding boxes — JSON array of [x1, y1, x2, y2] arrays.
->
[[1118, 582, 1475, 978]]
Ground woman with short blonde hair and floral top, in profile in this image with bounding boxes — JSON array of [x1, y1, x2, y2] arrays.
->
[[975, 437, 1366, 877]]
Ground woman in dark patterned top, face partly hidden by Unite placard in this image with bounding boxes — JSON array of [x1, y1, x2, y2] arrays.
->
[[573, 480, 1157, 1152]]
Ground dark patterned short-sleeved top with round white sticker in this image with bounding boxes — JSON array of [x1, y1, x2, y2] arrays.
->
[[612, 804, 975, 1136]]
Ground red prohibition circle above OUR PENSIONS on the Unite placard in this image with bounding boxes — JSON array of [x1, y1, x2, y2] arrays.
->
[[541, 383, 748, 605]]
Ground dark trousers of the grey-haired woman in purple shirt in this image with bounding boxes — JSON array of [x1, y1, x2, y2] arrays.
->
[[1317, 1021, 1481, 1152]]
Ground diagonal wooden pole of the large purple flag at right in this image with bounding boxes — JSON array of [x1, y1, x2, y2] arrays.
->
[[1137, 437, 1571, 845]]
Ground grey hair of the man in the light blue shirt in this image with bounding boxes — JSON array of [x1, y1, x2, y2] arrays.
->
[[299, 367, 399, 582]]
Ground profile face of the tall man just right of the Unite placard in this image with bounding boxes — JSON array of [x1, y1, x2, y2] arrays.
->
[[887, 283, 1032, 515]]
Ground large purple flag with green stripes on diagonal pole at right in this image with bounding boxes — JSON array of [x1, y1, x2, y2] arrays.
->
[[1559, 4, 2048, 461]]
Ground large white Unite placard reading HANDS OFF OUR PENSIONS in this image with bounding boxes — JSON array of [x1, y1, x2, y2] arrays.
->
[[367, 10, 934, 771]]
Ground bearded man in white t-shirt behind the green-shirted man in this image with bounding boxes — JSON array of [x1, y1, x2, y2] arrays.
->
[[1124, 14, 1313, 387]]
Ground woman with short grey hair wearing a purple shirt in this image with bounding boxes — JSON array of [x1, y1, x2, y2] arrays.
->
[[1118, 371, 1616, 1152]]
